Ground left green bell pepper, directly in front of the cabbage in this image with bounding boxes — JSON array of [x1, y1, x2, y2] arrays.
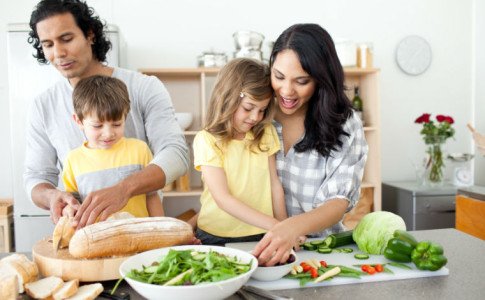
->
[[384, 230, 418, 262]]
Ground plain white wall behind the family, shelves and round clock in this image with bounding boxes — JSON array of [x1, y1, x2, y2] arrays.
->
[[0, 0, 476, 197]]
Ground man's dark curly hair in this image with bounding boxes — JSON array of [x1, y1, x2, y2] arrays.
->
[[28, 0, 111, 64]]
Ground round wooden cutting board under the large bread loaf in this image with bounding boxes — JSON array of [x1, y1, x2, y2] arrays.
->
[[32, 238, 129, 282]]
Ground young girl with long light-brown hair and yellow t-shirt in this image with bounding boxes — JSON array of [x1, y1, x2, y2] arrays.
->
[[193, 58, 287, 245]]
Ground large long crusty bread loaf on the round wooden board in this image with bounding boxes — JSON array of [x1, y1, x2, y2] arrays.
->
[[69, 217, 194, 258]]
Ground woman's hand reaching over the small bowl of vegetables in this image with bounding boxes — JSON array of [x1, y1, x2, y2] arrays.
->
[[253, 218, 301, 266]]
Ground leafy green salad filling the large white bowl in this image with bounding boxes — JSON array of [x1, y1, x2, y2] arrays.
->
[[126, 249, 252, 286]]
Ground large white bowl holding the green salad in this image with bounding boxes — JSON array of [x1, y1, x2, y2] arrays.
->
[[120, 245, 258, 300]]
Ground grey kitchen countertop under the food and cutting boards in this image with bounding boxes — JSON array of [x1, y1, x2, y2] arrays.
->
[[4, 228, 485, 300]]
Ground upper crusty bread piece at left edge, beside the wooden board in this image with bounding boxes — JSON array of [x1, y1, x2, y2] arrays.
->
[[0, 253, 39, 293]]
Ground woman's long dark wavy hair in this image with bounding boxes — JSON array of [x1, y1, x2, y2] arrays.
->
[[269, 24, 352, 157]]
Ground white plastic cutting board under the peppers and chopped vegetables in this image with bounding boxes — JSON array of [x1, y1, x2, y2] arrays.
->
[[226, 242, 449, 290]]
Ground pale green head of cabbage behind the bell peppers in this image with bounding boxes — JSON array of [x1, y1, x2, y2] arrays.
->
[[352, 211, 406, 254]]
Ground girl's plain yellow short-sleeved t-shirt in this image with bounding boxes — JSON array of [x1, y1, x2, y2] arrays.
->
[[193, 124, 280, 237]]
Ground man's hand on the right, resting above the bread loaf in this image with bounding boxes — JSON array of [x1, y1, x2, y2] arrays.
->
[[74, 184, 130, 229]]
